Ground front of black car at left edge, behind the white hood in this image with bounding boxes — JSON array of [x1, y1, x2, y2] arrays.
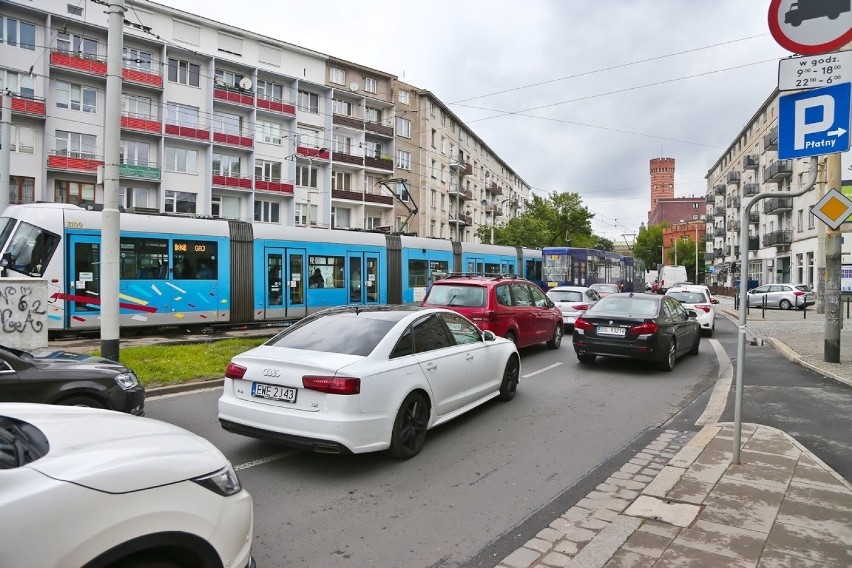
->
[[0, 345, 145, 416]]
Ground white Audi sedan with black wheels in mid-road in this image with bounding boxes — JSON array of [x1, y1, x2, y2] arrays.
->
[[219, 306, 520, 459]]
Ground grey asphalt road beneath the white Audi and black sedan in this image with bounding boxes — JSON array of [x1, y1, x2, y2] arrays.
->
[[147, 340, 717, 567]]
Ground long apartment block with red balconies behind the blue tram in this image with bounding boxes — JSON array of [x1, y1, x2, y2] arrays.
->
[[0, 0, 529, 240]]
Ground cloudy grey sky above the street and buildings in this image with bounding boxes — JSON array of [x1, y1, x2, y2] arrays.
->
[[160, 0, 804, 240]]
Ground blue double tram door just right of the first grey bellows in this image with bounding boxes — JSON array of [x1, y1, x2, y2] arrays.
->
[[264, 247, 307, 319]]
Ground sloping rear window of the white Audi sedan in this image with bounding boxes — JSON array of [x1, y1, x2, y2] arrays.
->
[[266, 312, 398, 357]]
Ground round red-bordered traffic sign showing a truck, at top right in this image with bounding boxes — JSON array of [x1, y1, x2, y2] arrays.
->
[[769, 0, 852, 55]]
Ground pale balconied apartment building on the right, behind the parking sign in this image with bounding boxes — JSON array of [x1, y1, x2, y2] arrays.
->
[[705, 90, 852, 287]]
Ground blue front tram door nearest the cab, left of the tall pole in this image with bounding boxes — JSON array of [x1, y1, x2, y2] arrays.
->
[[65, 235, 101, 328]]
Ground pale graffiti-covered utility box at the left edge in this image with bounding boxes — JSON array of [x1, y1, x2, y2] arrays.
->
[[0, 278, 47, 351]]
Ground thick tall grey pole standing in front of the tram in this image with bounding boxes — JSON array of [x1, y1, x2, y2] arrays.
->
[[101, 0, 124, 361]]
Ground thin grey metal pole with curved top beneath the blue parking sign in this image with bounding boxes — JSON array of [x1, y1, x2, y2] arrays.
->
[[732, 157, 817, 464]]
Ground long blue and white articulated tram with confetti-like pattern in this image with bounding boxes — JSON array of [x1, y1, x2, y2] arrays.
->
[[0, 203, 542, 331]]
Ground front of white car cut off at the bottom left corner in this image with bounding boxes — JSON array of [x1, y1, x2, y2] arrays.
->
[[0, 403, 255, 568]]
